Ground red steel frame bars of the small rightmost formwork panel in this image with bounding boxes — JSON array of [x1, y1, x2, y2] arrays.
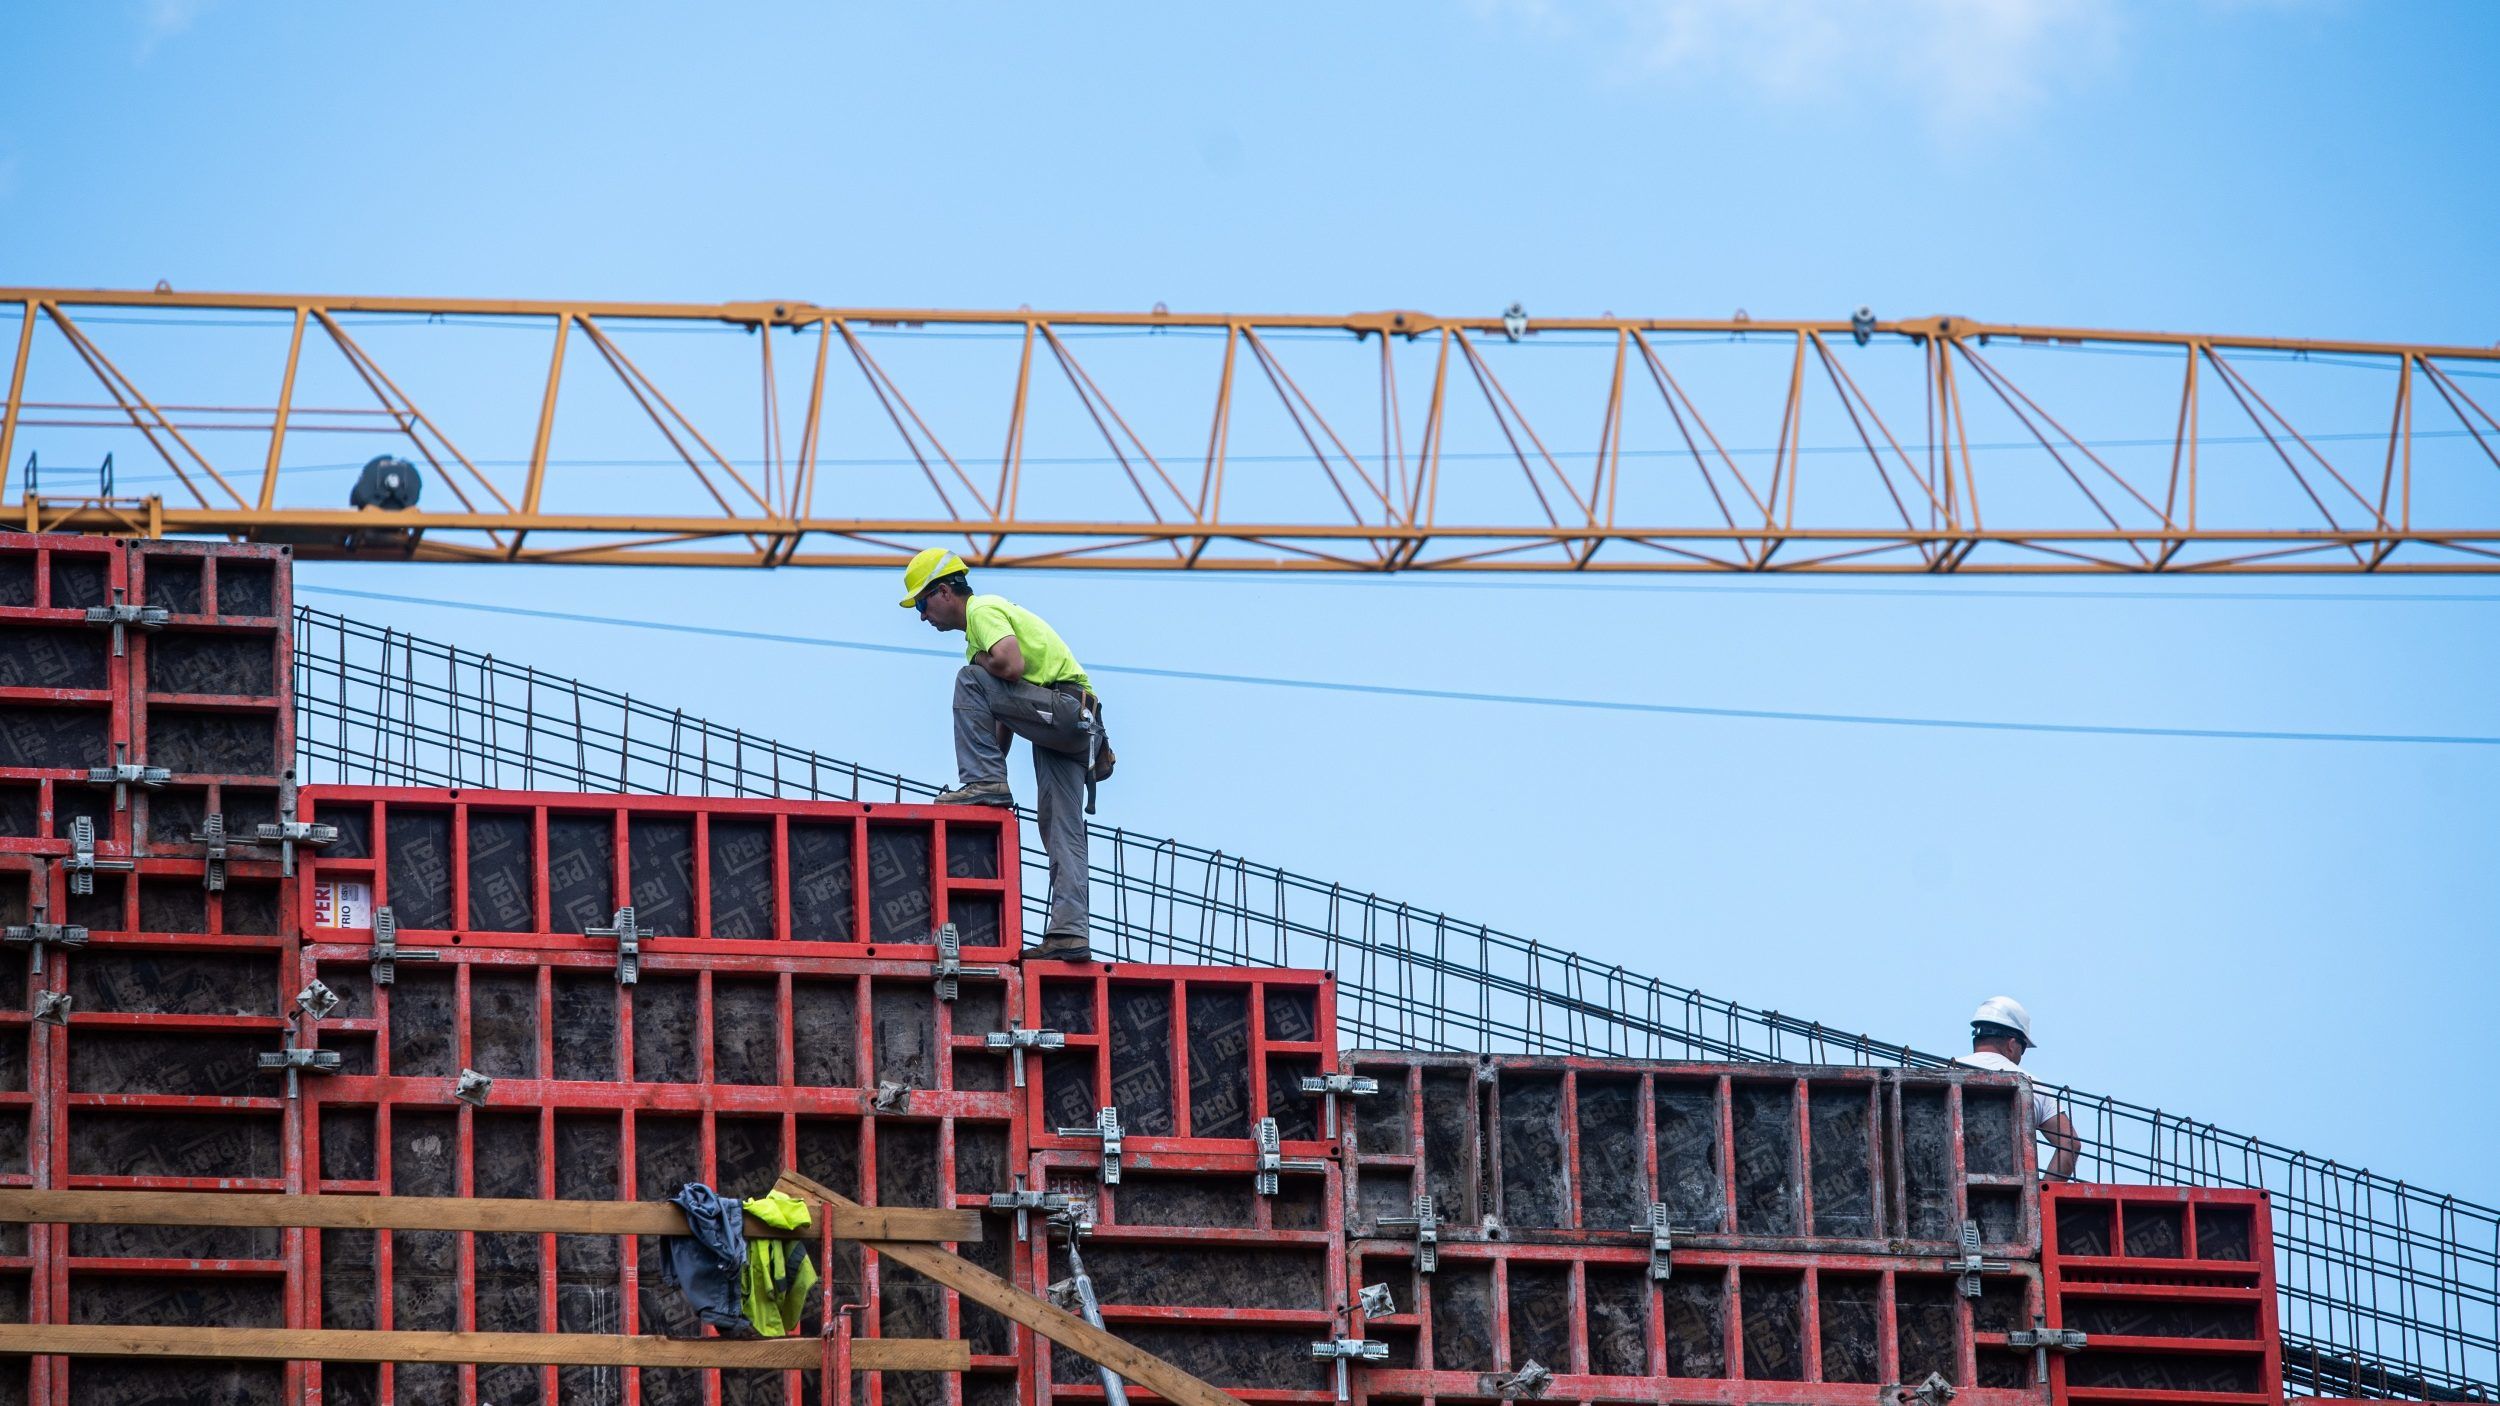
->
[[2040, 1183, 2283, 1406]]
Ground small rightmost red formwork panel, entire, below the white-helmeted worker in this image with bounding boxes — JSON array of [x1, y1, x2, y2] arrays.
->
[[2040, 1183, 2283, 1406]]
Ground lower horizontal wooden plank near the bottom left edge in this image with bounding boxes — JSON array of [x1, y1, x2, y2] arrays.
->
[[0, 1320, 973, 1371]]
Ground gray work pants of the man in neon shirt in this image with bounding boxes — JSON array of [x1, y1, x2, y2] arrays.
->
[[955, 663, 1088, 938]]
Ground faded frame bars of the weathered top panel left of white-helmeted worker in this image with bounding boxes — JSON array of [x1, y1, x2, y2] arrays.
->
[[1345, 1051, 2040, 1256]]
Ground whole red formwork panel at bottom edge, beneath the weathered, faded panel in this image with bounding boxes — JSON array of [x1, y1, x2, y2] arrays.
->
[[1348, 1241, 2045, 1406]]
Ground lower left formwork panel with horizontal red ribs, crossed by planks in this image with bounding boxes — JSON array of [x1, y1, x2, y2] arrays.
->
[[18, 840, 305, 1406]]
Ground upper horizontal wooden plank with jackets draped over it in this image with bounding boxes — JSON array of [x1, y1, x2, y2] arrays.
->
[[0, 1188, 983, 1241]]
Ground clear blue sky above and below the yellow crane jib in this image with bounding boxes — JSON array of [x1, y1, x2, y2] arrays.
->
[[0, 0, 2500, 1203]]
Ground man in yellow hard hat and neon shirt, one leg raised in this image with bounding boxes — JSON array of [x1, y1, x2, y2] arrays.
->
[[903, 548, 1113, 961]]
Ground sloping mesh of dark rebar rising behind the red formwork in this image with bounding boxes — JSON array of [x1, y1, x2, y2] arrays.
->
[[295, 608, 2500, 1401]]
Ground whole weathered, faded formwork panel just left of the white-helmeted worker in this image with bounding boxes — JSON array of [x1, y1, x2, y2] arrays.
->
[[1345, 1051, 2040, 1258]]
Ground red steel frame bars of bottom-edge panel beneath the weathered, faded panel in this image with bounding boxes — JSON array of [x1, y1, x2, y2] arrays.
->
[[1350, 1241, 2043, 1406]]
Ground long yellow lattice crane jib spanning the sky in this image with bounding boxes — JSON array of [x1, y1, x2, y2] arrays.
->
[[14, 288, 2500, 573]]
